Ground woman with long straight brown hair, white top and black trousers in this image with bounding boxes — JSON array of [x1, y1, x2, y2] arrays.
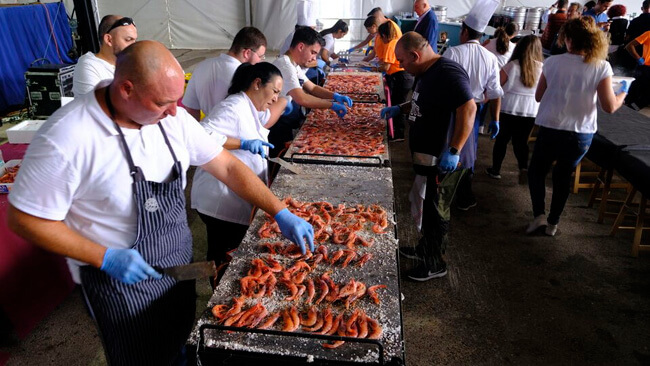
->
[[486, 35, 544, 184]]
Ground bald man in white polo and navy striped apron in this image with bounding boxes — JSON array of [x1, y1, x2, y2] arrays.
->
[[8, 41, 313, 365]]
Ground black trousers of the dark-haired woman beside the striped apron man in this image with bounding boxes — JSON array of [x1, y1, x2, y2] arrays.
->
[[198, 212, 248, 266]]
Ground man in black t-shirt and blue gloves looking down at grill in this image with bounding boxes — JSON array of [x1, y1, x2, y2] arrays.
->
[[382, 32, 476, 281]]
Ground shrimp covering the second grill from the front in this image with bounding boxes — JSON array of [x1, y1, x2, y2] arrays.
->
[[292, 104, 386, 156]]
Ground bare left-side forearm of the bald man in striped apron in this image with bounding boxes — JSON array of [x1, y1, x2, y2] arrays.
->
[[7, 205, 106, 268]]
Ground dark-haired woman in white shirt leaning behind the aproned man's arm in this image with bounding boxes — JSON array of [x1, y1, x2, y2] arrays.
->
[[191, 62, 287, 265]]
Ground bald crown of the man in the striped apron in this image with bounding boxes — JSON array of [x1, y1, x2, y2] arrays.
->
[[115, 41, 184, 86]]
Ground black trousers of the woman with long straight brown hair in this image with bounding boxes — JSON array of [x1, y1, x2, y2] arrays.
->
[[492, 112, 535, 172]]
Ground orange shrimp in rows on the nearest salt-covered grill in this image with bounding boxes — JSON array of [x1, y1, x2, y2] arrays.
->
[[212, 197, 388, 349]]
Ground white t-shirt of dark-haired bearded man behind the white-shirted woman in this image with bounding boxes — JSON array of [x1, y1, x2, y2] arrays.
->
[[183, 53, 241, 116]]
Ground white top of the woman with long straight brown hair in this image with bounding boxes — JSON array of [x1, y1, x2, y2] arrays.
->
[[501, 60, 544, 117]]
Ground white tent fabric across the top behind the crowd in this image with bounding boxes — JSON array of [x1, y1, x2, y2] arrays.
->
[[0, 0, 642, 49]]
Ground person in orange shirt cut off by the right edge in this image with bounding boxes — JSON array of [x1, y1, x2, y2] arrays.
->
[[625, 31, 650, 110]]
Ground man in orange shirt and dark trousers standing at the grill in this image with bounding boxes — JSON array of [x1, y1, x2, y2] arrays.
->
[[375, 20, 413, 142]]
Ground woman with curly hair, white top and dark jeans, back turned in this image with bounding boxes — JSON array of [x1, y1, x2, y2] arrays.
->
[[526, 17, 628, 236]]
